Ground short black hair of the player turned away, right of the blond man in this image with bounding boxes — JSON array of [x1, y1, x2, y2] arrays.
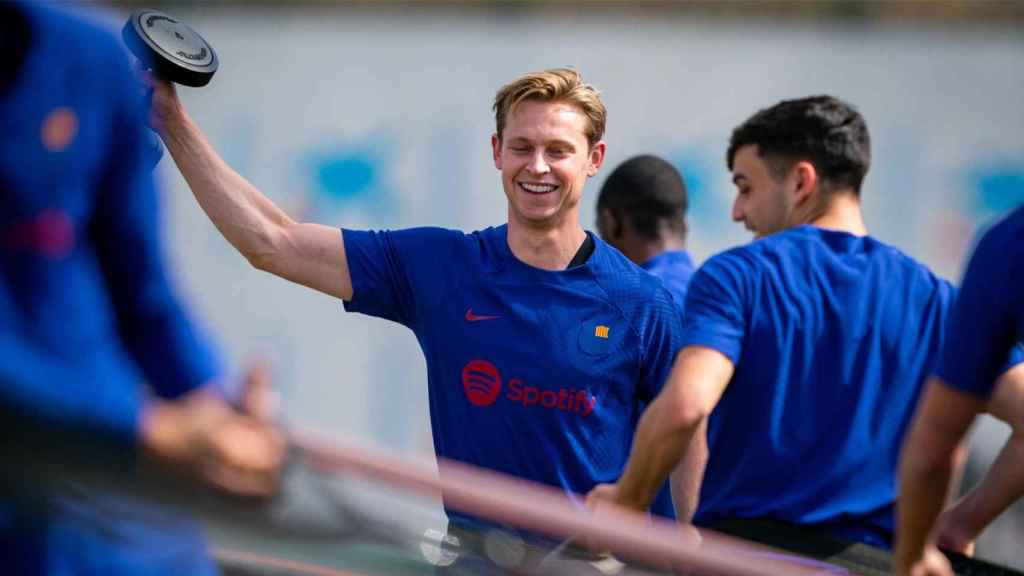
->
[[725, 95, 871, 195]]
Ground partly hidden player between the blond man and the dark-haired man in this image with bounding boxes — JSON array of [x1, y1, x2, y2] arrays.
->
[[597, 155, 693, 310]]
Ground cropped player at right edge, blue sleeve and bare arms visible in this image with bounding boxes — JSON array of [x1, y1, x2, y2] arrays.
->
[[896, 208, 1024, 576]]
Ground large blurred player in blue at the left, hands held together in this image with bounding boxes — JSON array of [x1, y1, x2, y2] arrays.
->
[[0, 2, 283, 575]]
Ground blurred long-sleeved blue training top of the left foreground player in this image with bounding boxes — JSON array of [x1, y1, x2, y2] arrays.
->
[[0, 4, 219, 575]]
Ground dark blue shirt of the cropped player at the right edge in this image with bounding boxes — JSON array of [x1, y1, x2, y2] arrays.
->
[[937, 207, 1024, 398]]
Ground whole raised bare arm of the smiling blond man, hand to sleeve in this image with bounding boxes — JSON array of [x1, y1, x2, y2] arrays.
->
[[150, 79, 352, 300]]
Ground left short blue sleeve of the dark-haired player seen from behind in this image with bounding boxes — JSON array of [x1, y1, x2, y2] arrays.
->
[[681, 251, 751, 364]]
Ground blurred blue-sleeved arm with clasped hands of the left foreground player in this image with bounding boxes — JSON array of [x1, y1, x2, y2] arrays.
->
[[100, 60, 283, 495]]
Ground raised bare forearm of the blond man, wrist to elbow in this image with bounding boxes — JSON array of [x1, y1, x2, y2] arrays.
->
[[161, 111, 294, 268]]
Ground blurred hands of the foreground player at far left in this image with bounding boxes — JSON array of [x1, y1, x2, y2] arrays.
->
[[142, 366, 286, 497]]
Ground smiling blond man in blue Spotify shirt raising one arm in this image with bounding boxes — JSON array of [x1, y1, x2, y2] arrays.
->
[[148, 69, 681, 537]]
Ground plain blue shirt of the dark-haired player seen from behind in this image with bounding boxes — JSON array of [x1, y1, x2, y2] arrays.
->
[[683, 225, 955, 547]]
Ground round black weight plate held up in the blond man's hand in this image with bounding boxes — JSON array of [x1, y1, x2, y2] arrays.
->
[[121, 10, 218, 87]]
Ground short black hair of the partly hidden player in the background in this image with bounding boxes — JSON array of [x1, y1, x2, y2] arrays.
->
[[597, 155, 687, 239]]
